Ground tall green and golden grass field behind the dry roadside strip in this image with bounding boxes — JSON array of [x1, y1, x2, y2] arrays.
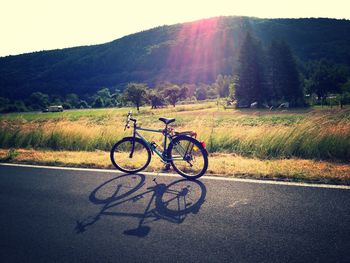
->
[[0, 102, 350, 162]]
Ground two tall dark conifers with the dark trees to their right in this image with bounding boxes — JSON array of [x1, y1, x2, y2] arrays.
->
[[235, 33, 350, 107]]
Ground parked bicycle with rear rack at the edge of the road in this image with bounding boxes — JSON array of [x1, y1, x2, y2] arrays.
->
[[110, 112, 208, 180]]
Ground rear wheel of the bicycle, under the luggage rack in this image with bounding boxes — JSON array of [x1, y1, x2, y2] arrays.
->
[[169, 136, 208, 180]]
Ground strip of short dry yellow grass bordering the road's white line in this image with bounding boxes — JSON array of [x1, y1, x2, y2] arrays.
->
[[0, 149, 350, 185]]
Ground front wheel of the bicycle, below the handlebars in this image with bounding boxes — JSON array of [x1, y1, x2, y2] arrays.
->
[[110, 137, 151, 173]]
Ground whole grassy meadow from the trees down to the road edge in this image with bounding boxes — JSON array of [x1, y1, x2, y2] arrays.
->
[[0, 102, 350, 185]]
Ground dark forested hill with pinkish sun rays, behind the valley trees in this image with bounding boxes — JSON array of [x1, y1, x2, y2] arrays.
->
[[0, 17, 350, 98]]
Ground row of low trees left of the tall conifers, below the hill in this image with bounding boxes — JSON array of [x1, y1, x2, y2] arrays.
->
[[0, 75, 233, 113]]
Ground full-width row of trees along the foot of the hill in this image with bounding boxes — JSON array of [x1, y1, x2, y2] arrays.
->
[[0, 33, 350, 113]]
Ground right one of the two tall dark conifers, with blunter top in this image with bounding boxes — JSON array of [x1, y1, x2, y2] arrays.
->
[[268, 41, 304, 105]]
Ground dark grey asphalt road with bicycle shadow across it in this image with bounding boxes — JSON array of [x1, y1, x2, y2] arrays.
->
[[0, 165, 350, 262]]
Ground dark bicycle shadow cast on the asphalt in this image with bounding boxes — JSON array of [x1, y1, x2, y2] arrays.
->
[[75, 174, 206, 237]]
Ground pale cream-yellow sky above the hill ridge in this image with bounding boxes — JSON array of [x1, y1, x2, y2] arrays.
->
[[0, 0, 350, 56]]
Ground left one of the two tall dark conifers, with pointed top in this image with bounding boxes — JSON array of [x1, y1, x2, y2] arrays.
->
[[235, 33, 267, 106]]
